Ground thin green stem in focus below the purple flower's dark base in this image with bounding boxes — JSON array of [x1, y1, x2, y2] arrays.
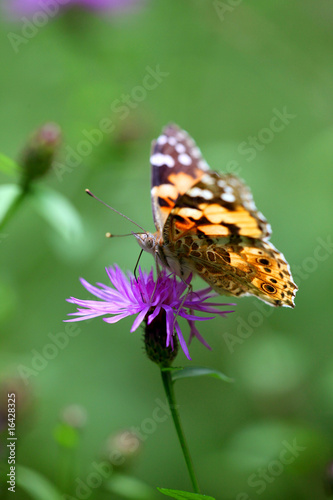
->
[[161, 369, 200, 493]]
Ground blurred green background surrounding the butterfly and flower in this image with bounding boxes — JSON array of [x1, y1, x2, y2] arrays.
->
[[0, 0, 333, 500]]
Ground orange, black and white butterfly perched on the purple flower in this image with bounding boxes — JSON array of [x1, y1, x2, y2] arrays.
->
[[135, 124, 297, 307]]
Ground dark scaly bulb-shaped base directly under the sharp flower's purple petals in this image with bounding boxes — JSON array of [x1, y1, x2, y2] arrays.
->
[[144, 309, 178, 367]]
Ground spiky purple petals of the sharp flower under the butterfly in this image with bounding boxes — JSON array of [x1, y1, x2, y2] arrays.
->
[[66, 266, 234, 359]]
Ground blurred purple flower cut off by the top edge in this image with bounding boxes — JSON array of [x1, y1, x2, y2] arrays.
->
[[6, 0, 142, 17]]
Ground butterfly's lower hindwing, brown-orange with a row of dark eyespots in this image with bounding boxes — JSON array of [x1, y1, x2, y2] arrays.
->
[[164, 235, 297, 307]]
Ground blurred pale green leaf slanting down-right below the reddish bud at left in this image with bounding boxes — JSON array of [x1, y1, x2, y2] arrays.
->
[[32, 186, 83, 243]]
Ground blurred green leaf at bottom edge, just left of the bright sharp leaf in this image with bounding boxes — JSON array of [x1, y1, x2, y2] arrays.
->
[[105, 474, 156, 500]]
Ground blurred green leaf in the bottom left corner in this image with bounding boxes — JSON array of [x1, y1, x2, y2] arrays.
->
[[16, 465, 63, 500]]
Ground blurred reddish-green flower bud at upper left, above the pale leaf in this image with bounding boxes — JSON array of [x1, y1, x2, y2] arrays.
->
[[19, 123, 61, 189]]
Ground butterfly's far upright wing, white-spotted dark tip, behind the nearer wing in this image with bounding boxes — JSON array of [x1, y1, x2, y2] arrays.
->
[[150, 125, 209, 234]]
